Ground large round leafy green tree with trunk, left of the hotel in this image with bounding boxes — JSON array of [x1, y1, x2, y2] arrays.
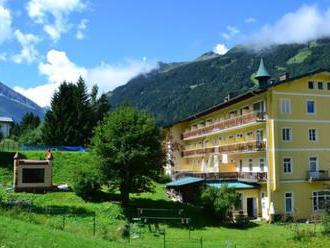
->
[[92, 106, 162, 206]]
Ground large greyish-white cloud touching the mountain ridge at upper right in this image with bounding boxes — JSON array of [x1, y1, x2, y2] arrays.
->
[[247, 5, 330, 47]]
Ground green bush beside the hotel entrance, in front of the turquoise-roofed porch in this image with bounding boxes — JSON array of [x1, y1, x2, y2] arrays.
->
[[201, 185, 240, 221]]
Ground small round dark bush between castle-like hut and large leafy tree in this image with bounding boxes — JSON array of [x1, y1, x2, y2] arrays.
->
[[73, 167, 102, 200]]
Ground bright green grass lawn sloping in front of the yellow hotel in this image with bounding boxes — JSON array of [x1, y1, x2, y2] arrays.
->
[[0, 152, 330, 248]]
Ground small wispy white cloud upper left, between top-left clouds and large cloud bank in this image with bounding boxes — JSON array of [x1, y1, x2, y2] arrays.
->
[[12, 30, 40, 64]]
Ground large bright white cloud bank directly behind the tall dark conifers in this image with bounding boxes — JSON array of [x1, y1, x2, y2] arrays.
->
[[14, 50, 158, 106]]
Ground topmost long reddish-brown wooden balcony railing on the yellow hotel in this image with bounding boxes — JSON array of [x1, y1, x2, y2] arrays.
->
[[183, 112, 265, 139]]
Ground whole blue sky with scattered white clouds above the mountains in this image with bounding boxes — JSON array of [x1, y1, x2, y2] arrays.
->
[[0, 0, 330, 106]]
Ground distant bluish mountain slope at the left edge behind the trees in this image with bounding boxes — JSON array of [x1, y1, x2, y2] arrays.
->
[[0, 82, 45, 121]]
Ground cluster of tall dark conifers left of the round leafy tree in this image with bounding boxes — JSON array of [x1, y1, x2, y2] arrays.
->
[[42, 78, 109, 146]]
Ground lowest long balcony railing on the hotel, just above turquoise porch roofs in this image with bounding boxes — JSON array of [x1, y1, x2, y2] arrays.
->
[[173, 172, 267, 183]]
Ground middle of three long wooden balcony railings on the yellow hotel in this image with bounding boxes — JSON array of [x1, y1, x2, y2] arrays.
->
[[182, 141, 266, 157]]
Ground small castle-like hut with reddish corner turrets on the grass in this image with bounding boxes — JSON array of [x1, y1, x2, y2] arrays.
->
[[14, 150, 53, 192]]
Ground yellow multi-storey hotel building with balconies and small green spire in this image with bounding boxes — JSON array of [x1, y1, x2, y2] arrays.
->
[[165, 60, 330, 219]]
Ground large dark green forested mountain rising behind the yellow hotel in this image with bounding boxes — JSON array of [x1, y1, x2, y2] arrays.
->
[[110, 39, 330, 125]]
